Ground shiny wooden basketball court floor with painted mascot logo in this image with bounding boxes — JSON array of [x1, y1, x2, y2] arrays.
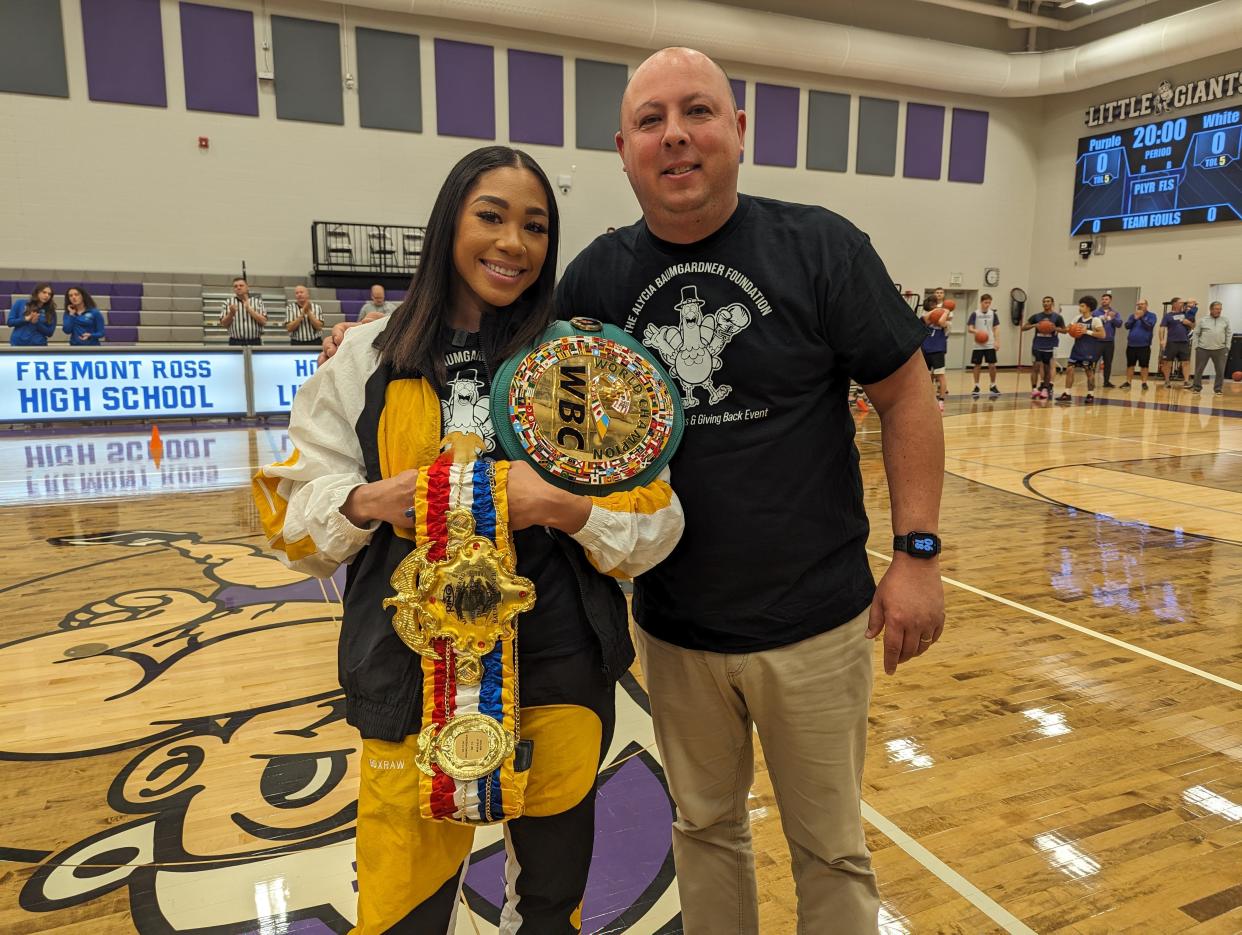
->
[[0, 373, 1242, 935]]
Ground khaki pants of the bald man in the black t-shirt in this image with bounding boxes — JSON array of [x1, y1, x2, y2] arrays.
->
[[637, 612, 879, 935]]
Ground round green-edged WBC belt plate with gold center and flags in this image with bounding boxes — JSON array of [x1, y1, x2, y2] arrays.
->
[[491, 318, 684, 495]]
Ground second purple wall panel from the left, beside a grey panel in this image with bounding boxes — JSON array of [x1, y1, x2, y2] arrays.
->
[[181, 2, 258, 117]]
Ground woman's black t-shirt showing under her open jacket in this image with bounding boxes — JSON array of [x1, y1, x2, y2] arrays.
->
[[440, 334, 596, 662]]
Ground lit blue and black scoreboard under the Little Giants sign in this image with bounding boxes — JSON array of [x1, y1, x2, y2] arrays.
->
[[1069, 103, 1242, 235]]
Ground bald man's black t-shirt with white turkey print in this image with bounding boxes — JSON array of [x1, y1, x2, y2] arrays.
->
[[558, 195, 925, 652]]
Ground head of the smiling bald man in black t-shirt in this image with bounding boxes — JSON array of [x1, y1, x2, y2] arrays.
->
[[616, 50, 746, 233]]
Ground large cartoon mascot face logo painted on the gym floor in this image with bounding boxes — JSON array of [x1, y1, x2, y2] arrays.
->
[[0, 530, 681, 935]]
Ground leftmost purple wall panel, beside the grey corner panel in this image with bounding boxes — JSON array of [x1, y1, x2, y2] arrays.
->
[[82, 0, 168, 107]]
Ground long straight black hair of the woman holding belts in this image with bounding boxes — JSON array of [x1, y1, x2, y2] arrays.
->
[[375, 147, 560, 387]]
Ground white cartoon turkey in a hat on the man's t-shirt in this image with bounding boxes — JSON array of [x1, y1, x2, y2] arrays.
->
[[642, 286, 750, 409]]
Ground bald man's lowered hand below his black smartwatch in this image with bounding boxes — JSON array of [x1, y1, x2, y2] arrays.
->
[[867, 554, 944, 675]]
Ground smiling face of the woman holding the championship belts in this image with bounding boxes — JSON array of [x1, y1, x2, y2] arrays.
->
[[453, 166, 548, 310]]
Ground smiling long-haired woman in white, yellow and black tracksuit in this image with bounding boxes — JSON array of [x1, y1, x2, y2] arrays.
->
[[255, 147, 682, 935]]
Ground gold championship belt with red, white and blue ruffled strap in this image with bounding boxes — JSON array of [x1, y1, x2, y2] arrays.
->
[[384, 435, 535, 824]]
